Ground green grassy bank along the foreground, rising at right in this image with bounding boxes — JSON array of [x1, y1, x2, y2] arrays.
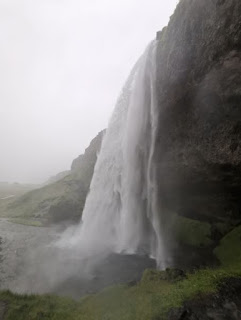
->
[[0, 226, 241, 320]]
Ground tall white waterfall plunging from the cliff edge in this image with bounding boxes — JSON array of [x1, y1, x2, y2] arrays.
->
[[58, 41, 168, 264]]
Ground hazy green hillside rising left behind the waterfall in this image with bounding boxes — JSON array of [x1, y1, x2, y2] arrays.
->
[[0, 131, 104, 223]]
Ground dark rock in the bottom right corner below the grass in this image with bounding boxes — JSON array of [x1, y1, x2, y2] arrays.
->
[[167, 278, 241, 320]]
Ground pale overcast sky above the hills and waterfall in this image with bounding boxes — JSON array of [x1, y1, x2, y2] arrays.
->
[[0, 0, 177, 183]]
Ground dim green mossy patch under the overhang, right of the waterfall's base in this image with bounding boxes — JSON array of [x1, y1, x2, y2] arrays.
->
[[172, 216, 212, 247]]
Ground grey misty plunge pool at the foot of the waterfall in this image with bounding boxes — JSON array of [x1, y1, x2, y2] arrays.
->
[[0, 219, 155, 298]]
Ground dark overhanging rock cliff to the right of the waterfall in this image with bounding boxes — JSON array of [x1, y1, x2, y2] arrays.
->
[[155, 0, 241, 258]]
